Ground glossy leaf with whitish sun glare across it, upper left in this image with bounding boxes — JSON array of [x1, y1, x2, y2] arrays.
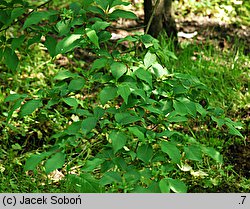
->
[[55, 34, 82, 55]]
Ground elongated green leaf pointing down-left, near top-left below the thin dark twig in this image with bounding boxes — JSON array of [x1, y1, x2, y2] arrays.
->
[[23, 11, 58, 29]]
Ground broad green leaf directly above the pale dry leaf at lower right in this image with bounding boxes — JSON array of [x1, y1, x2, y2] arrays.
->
[[161, 141, 181, 164]]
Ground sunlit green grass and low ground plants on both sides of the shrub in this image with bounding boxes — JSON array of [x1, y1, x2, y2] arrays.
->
[[0, 0, 250, 192]]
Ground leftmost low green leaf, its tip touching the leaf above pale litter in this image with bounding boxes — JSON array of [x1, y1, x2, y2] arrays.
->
[[24, 152, 51, 171]]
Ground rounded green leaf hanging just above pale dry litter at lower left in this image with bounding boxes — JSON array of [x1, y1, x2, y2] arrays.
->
[[45, 152, 65, 174]]
